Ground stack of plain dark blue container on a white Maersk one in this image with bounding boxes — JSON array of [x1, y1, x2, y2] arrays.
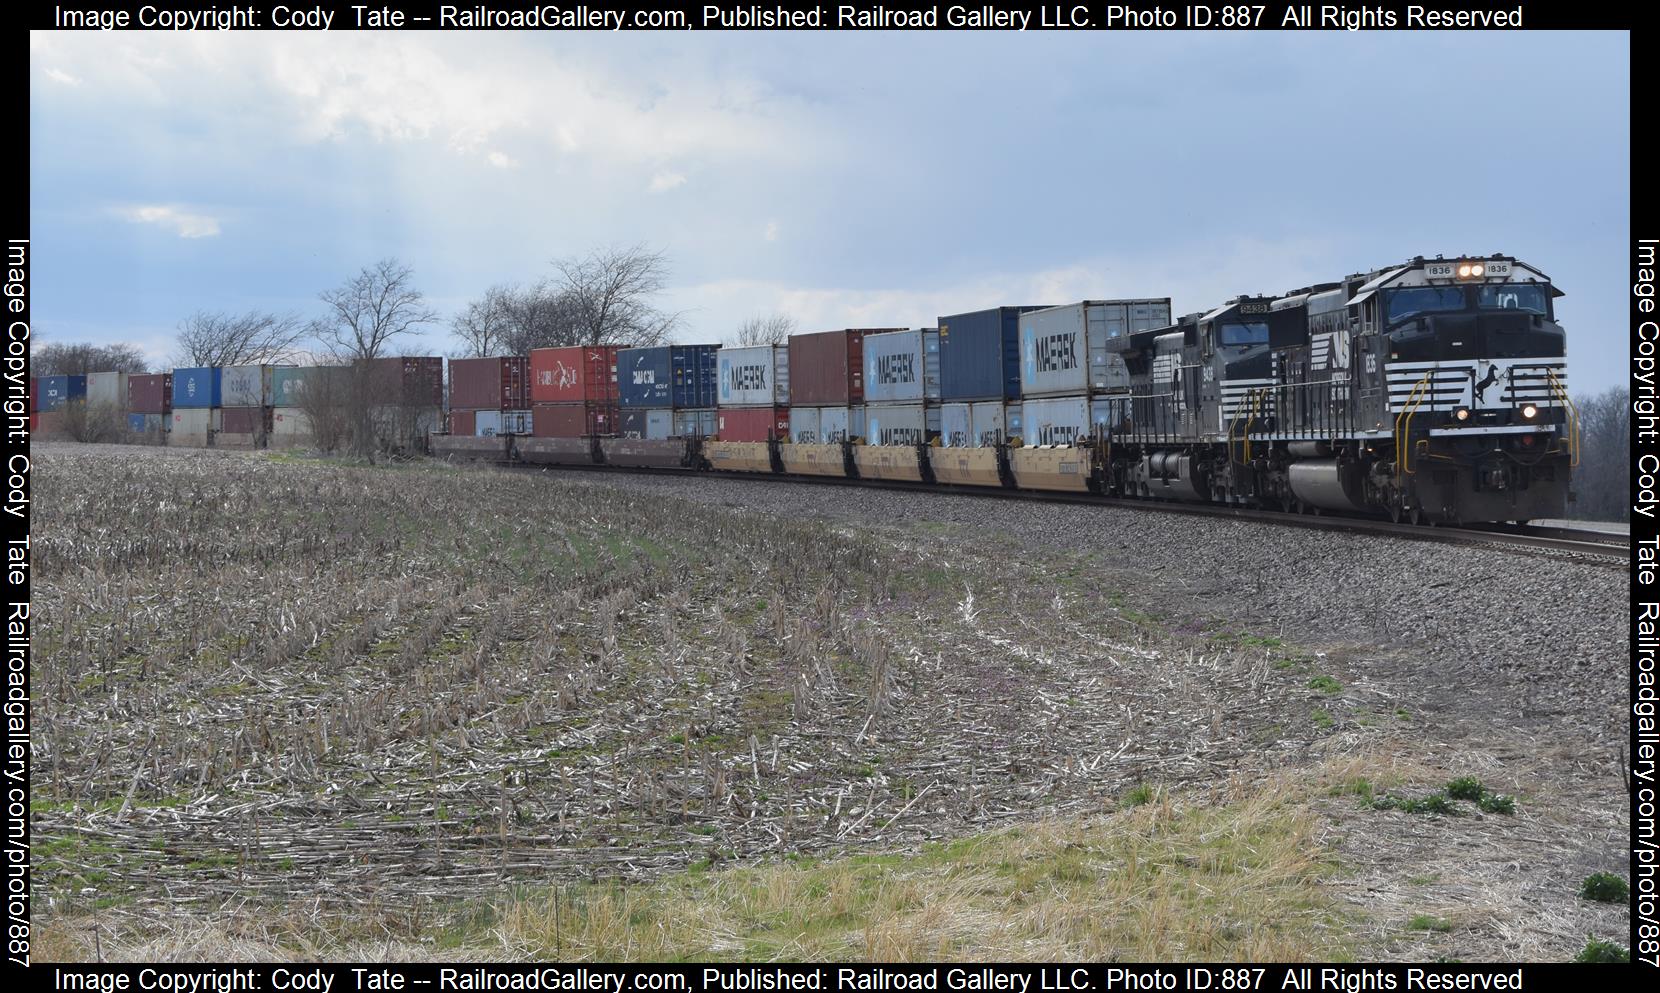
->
[[940, 306, 1046, 448]]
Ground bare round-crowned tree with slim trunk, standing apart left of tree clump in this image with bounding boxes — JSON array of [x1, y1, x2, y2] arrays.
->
[[312, 257, 438, 458]]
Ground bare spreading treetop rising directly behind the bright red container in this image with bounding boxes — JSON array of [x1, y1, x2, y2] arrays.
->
[[553, 244, 681, 345]]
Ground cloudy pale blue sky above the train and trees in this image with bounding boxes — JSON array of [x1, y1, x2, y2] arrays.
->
[[30, 32, 1630, 390]]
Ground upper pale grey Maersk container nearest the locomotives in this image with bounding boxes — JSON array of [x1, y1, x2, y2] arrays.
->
[[1021, 297, 1170, 397]]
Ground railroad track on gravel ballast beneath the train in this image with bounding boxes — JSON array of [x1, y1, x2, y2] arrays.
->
[[493, 462, 1632, 560]]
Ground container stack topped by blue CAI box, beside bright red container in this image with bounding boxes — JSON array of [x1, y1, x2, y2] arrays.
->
[[618, 345, 719, 442]]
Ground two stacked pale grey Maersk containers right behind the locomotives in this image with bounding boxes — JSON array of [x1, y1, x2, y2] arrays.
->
[[1019, 297, 1170, 445]]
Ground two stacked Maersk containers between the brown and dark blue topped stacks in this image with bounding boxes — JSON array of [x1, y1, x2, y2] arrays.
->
[[865, 327, 940, 445]]
